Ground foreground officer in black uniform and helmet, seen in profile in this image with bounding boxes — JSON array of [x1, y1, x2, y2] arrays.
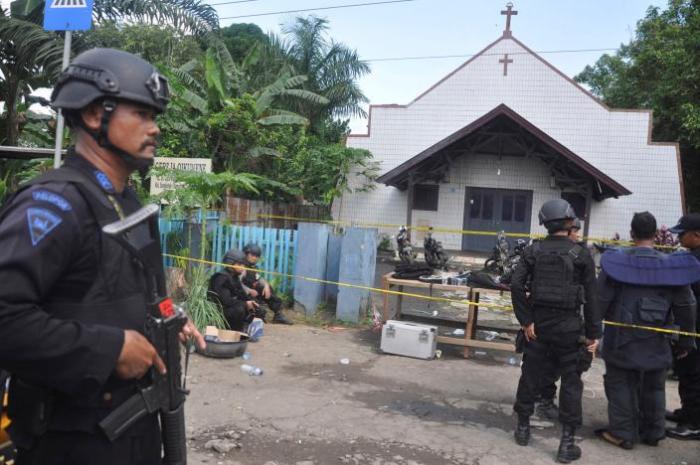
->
[[0, 49, 204, 465]]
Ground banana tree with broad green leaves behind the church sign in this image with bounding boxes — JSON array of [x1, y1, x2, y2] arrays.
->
[[162, 40, 327, 170]]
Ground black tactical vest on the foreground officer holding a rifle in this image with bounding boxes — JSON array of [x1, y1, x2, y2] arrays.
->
[[0, 166, 147, 432]]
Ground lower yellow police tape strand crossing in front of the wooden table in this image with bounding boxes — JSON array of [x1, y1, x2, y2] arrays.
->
[[163, 253, 700, 338]]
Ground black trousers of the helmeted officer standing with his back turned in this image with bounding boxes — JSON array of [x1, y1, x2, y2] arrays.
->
[[513, 331, 583, 428]]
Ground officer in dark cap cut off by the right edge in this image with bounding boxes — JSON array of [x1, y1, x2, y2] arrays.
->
[[666, 213, 700, 440]]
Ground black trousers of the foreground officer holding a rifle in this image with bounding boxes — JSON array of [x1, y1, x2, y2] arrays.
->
[[15, 415, 162, 465]]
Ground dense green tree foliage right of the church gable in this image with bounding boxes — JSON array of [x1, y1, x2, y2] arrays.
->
[[575, 0, 700, 211]]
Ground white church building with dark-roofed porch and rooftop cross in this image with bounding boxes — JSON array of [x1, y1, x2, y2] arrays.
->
[[333, 6, 684, 250]]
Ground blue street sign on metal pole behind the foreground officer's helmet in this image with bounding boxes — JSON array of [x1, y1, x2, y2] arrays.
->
[[44, 0, 94, 168]]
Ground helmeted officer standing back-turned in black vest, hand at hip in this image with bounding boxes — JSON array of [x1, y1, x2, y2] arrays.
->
[[511, 199, 601, 463]]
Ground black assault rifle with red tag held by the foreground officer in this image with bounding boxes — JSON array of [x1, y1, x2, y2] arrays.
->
[[100, 204, 188, 465]]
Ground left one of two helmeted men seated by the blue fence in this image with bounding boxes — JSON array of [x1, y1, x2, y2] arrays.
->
[[209, 249, 264, 331]]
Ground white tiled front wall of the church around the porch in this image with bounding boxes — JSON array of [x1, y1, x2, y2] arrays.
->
[[341, 38, 682, 245]]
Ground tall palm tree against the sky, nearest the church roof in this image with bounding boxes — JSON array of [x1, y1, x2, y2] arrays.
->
[[281, 16, 370, 124]]
